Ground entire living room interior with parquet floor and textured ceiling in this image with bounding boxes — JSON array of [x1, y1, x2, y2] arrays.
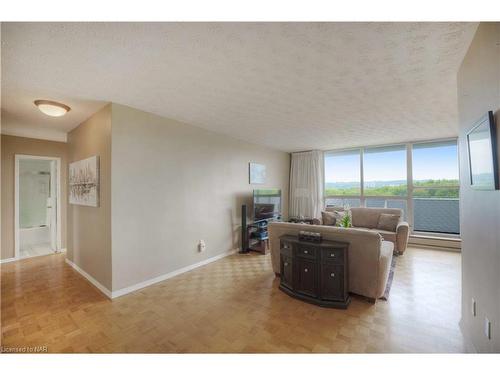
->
[[0, 0, 500, 374]]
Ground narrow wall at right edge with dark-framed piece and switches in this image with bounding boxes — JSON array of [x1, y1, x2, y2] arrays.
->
[[458, 23, 500, 352]]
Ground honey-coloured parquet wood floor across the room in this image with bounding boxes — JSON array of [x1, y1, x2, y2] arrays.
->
[[1, 248, 465, 353]]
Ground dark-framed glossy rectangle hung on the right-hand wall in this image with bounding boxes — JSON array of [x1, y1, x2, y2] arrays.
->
[[467, 111, 499, 190]]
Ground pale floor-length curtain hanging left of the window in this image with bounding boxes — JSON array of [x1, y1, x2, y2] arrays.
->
[[289, 151, 324, 218]]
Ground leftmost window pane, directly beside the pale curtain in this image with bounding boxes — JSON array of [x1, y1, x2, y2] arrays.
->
[[325, 150, 361, 196]]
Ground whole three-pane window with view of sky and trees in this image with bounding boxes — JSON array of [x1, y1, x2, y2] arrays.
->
[[325, 140, 460, 234]]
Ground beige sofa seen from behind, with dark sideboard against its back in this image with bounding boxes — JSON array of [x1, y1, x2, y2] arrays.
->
[[269, 222, 394, 300]]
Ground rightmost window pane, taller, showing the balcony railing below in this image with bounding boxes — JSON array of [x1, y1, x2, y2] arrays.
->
[[412, 141, 460, 233]]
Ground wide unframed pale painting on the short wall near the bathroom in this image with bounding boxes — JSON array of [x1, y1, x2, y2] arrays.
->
[[69, 156, 99, 207]]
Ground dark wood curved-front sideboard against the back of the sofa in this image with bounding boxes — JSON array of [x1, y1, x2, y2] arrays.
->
[[280, 235, 351, 309]]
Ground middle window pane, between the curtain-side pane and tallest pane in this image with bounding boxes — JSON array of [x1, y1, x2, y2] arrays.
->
[[363, 145, 407, 197]]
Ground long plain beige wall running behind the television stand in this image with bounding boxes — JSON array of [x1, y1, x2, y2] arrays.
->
[[111, 104, 290, 291]]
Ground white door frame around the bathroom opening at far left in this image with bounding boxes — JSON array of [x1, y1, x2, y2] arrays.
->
[[14, 154, 62, 259]]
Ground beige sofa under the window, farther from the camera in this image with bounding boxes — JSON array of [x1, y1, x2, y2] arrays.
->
[[325, 207, 409, 254]]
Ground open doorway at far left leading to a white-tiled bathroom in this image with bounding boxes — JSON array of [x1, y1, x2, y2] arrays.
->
[[14, 155, 61, 259]]
